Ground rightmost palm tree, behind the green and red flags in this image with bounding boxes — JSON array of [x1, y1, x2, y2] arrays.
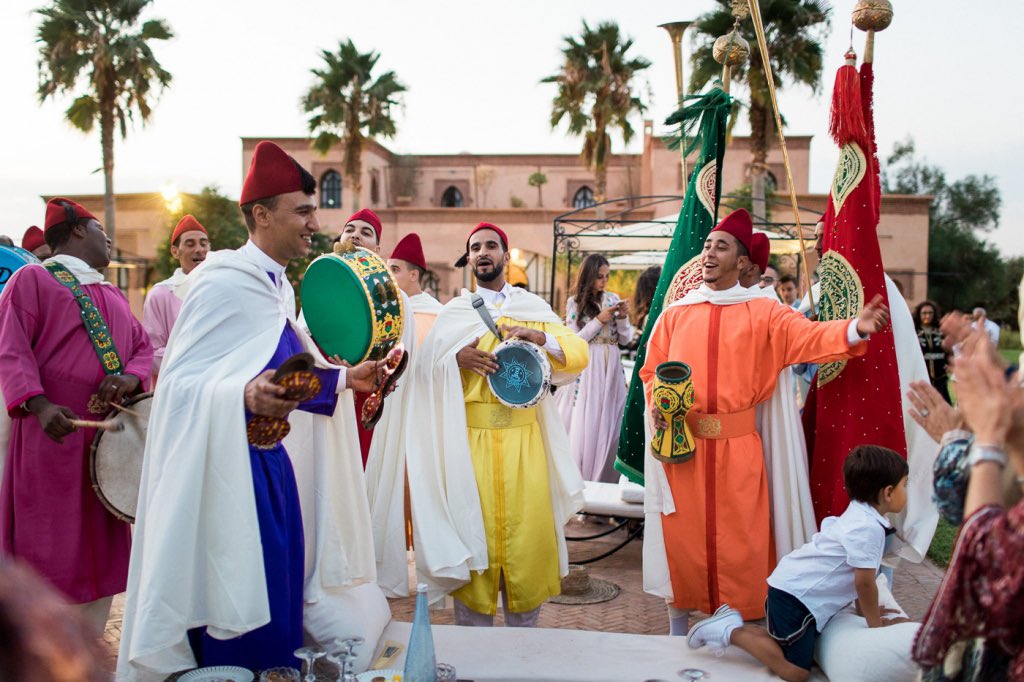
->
[[690, 0, 830, 218]]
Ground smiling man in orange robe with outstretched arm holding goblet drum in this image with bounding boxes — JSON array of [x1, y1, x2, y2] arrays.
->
[[640, 209, 889, 634]]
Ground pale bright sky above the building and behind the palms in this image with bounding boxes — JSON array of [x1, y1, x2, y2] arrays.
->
[[0, 0, 1024, 255]]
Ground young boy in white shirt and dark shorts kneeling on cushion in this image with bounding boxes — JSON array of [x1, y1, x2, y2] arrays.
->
[[686, 445, 908, 682]]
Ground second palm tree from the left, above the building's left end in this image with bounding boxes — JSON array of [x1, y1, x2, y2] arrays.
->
[[302, 39, 406, 209]]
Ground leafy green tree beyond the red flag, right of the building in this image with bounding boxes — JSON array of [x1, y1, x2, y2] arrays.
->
[[882, 138, 1024, 323]]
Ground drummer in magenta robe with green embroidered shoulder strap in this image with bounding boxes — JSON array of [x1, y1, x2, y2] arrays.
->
[[0, 199, 153, 632]]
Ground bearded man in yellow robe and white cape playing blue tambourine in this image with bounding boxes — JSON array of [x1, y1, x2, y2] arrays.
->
[[407, 223, 589, 627]]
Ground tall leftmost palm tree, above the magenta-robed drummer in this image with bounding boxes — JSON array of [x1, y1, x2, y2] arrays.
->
[[36, 0, 174, 249]]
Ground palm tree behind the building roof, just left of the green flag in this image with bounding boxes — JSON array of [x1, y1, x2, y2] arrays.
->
[[541, 22, 650, 203]]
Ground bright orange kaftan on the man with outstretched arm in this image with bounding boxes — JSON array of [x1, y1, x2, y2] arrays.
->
[[640, 298, 866, 620]]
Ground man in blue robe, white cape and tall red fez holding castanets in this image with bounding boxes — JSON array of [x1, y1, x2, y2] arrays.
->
[[118, 141, 383, 680]]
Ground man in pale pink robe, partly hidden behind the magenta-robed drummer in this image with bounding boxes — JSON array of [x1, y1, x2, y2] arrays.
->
[[142, 214, 210, 376]]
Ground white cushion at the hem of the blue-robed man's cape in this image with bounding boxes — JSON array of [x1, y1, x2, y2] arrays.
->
[[302, 583, 391, 673]]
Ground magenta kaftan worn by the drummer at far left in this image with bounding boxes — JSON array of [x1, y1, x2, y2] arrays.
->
[[0, 265, 153, 603]]
